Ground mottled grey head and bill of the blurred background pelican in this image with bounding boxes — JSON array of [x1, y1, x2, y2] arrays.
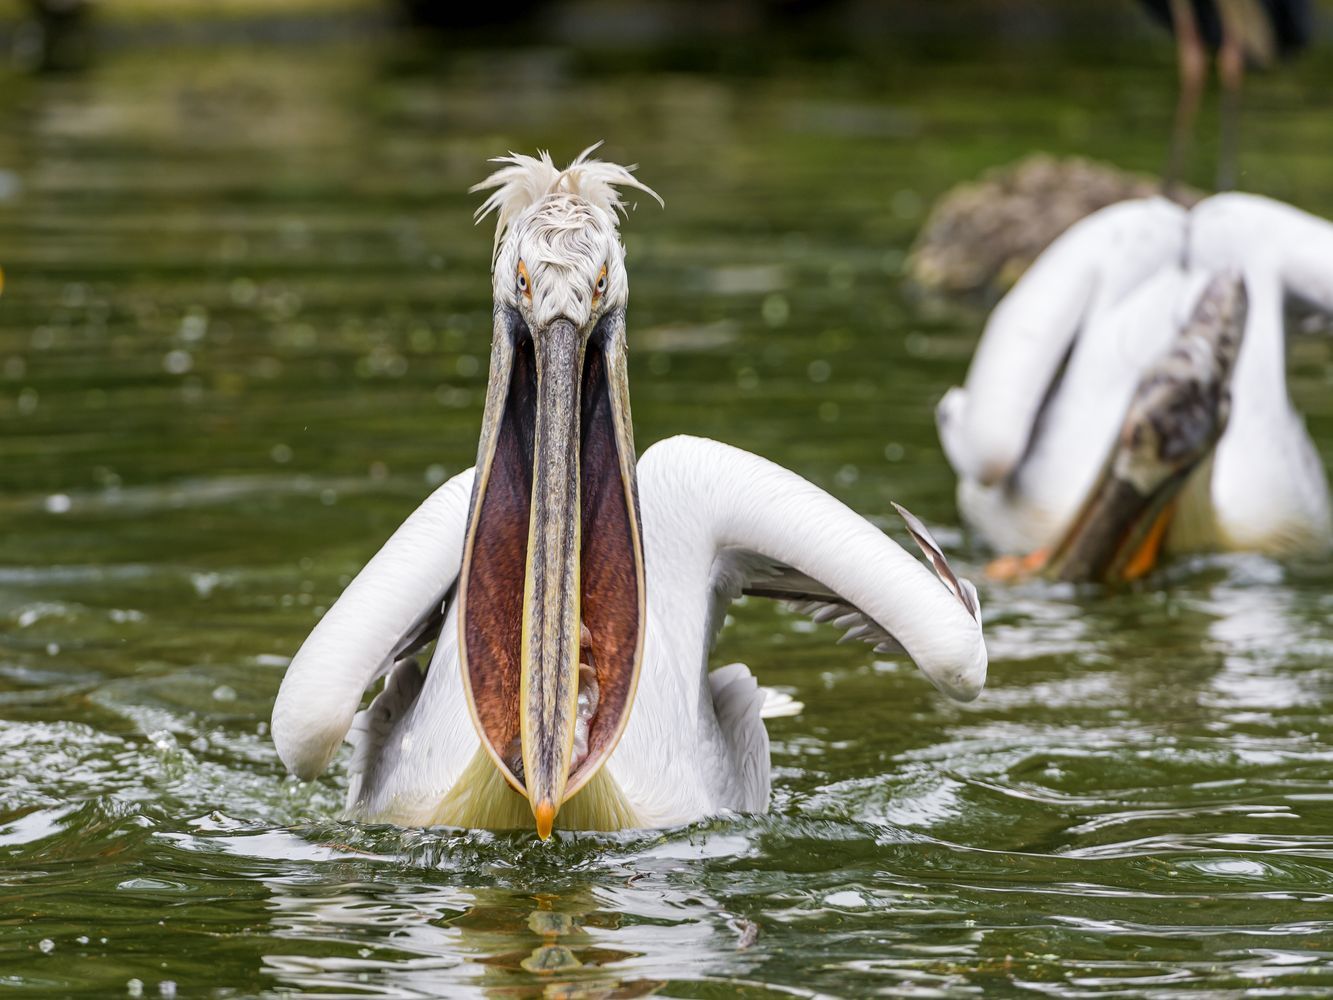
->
[[1042, 275, 1248, 583]]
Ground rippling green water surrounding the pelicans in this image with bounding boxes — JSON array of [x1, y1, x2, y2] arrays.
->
[[0, 27, 1333, 997]]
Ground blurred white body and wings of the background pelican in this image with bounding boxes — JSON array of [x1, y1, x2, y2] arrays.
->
[[936, 193, 1333, 576]]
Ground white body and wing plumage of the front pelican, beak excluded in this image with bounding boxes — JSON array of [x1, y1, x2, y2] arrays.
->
[[273, 437, 986, 827]]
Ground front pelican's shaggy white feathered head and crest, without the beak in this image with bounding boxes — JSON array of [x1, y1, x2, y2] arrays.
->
[[472, 143, 663, 328]]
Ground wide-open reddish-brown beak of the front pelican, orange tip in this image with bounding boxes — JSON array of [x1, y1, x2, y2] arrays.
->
[[459, 308, 645, 840]]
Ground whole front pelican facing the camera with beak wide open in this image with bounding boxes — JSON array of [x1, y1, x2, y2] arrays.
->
[[272, 147, 986, 840]]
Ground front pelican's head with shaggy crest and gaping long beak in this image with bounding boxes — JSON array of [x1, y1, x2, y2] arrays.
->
[[459, 147, 660, 839]]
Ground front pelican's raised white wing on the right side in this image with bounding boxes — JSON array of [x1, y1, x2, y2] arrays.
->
[[640, 437, 986, 701]]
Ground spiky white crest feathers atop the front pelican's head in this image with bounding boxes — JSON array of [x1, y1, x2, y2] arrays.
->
[[468, 141, 664, 264]]
